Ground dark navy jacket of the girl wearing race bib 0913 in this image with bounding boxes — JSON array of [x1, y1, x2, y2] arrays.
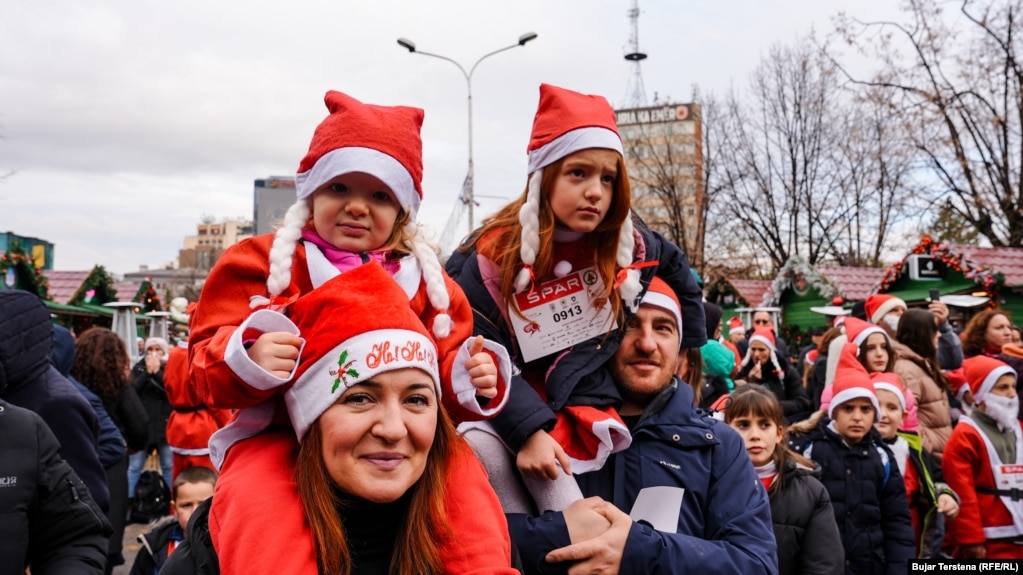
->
[[446, 212, 707, 451]]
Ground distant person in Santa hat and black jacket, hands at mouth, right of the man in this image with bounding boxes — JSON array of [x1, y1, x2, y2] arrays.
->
[[736, 326, 810, 417]]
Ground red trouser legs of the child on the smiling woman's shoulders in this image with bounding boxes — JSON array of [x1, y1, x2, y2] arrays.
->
[[210, 428, 519, 575]]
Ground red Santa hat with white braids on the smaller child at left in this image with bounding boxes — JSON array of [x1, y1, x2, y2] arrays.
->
[[252, 90, 451, 338]]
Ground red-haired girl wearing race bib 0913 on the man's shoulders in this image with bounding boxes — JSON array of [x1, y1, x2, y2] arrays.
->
[[447, 84, 707, 513]]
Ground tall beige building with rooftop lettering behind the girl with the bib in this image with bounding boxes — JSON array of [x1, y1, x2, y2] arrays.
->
[[615, 103, 707, 270]]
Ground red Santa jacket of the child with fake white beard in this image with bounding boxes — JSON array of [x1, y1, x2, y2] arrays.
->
[[941, 417, 1023, 559]]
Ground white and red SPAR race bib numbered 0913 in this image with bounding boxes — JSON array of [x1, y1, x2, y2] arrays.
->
[[508, 267, 618, 362]]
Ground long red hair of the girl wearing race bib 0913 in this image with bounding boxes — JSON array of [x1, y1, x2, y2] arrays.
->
[[459, 156, 632, 317]]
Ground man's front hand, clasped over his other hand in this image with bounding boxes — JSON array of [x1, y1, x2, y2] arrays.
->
[[546, 497, 632, 575]]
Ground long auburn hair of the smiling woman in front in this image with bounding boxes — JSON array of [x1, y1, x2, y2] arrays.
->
[[296, 399, 463, 575]]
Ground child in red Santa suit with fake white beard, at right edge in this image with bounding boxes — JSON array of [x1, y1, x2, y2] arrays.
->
[[941, 355, 1023, 560]]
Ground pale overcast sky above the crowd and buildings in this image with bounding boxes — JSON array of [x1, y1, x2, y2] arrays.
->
[[0, 0, 897, 274]]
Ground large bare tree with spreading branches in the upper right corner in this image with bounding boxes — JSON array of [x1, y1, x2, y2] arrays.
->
[[836, 0, 1023, 247]]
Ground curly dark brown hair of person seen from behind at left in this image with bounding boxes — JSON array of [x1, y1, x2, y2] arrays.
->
[[71, 327, 131, 401]]
